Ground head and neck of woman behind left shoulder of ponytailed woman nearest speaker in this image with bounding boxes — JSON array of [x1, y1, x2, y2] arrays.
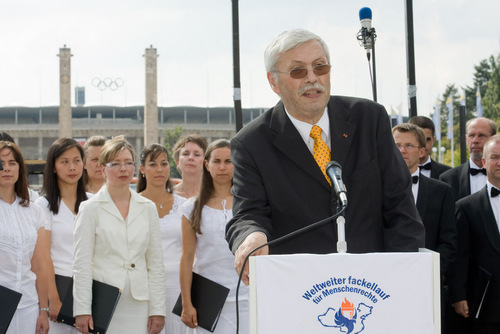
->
[[172, 134, 208, 198]]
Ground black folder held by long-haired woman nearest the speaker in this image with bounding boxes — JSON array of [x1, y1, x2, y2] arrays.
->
[[172, 272, 229, 332]]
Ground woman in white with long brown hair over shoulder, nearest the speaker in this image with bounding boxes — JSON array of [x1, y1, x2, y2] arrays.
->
[[180, 139, 249, 334]]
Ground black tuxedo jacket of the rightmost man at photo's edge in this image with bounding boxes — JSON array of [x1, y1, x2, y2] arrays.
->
[[449, 187, 500, 322]]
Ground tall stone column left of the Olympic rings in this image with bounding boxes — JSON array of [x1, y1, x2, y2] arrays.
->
[[58, 45, 73, 138]]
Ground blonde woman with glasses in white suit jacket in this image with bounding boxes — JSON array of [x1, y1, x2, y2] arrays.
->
[[73, 136, 166, 334]]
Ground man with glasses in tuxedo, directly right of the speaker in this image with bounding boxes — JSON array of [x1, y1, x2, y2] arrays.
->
[[392, 123, 457, 278]]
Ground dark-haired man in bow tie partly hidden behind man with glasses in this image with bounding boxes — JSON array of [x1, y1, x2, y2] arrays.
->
[[408, 116, 451, 179]]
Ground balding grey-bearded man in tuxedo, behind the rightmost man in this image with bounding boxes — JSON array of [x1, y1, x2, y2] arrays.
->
[[439, 117, 497, 201]]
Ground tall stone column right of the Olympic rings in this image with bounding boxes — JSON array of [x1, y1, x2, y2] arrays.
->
[[144, 45, 158, 146]]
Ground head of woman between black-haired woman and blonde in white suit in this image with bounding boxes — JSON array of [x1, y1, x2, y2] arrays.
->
[[83, 136, 107, 194]]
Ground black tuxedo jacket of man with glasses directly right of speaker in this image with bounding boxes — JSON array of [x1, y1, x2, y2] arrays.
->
[[417, 174, 457, 275]]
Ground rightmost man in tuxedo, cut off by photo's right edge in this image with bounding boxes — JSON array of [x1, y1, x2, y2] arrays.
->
[[450, 135, 500, 334]]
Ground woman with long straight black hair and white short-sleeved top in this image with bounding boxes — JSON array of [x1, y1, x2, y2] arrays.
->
[[35, 138, 87, 334]]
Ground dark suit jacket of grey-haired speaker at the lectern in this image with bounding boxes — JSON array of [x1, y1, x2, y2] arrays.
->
[[226, 96, 425, 253]]
